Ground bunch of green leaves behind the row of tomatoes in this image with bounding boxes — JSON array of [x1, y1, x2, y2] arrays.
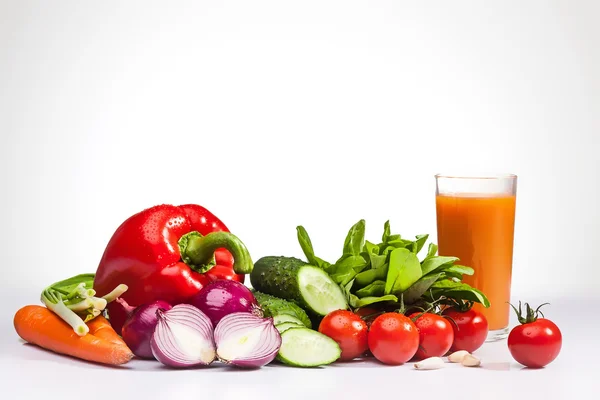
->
[[297, 220, 489, 309]]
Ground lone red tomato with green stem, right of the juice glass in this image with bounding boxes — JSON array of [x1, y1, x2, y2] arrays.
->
[[508, 302, 562, 368]]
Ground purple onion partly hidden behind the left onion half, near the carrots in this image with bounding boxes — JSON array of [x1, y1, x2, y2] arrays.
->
[[121, 300, 172, 359]]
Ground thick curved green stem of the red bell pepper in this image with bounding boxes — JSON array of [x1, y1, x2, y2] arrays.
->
[[179, 232, 254, 274]]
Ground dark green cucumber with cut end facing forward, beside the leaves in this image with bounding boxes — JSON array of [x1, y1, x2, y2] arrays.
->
[[250, 256, 348, 316]]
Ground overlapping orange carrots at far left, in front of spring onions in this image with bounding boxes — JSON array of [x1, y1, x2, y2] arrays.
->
[[14, 305, 133, 365]]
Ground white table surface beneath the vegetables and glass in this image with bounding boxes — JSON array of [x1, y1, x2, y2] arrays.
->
[[0, 290, 600, 400]]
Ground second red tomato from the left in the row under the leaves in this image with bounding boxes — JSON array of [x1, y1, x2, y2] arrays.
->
[[368, 312, 419, 365]]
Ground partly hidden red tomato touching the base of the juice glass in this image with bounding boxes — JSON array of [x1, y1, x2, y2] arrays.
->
[[442, 307, 488, 353]]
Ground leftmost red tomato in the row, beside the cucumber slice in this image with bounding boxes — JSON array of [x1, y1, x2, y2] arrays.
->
[[319, 310, 368, 361]]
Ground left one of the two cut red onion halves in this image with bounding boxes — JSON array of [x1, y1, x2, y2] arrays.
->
[[150, 304, 216, 368]]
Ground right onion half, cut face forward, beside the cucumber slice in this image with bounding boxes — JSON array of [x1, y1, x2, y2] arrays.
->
[[214, 312, 281, 368]]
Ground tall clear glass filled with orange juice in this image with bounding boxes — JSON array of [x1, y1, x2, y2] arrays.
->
[[435, 174, 517, 341]]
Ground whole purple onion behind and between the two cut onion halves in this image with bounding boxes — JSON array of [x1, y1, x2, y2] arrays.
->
[[189, 279, 260, 326]]
